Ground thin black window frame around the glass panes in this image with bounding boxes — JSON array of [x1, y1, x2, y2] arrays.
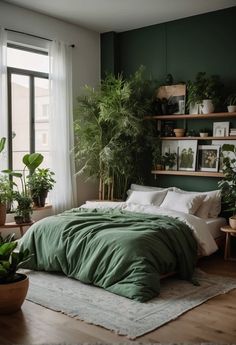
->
[[7, 43, 49, 169]]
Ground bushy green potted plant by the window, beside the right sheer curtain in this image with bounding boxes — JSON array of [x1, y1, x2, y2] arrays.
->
[[27, 168, 56, 207]]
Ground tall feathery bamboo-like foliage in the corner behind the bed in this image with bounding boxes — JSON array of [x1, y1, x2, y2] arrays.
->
[[75, 68, 153, 198]]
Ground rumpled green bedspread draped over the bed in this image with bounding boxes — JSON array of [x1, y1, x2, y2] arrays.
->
[[21, 209, 197, 302]]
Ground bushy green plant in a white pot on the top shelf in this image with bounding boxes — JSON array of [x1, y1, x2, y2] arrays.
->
[[187, 72, 222, 114]]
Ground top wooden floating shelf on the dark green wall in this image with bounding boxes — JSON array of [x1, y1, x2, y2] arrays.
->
[[144, 112, 236, 120]]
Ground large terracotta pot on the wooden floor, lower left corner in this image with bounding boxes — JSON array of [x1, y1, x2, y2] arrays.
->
[[0, 273, 29, 314]]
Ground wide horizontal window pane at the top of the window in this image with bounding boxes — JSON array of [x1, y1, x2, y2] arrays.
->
[[7, 47, 49, 73]]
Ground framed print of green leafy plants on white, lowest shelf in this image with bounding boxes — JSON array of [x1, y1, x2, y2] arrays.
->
[[178, 140, 197, 171]]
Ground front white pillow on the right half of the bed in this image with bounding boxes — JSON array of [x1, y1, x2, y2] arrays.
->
[[160, 191, 206, 214]]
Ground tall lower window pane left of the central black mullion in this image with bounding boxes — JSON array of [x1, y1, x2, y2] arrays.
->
[[11, 74, 30, 170]]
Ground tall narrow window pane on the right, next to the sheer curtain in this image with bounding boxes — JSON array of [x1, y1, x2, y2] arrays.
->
[[35, 78, 50, 168]]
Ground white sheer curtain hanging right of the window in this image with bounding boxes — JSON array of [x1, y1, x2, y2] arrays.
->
[[49, 41, 76, 213]]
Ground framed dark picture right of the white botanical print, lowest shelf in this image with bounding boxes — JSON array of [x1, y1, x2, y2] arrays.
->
[[198, 145, 220, 172]]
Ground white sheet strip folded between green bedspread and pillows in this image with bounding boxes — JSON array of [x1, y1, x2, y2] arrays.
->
[[81, 201, 218, 256]]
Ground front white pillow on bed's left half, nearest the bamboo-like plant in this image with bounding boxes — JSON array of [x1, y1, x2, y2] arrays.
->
[[126, 190, 167, 206]]
